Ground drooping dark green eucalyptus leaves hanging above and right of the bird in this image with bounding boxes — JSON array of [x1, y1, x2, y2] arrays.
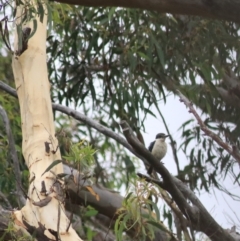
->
[[48, 5, 239, 196]]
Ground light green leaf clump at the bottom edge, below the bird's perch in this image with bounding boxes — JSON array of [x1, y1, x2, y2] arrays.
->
[[114, 180, 165, 240]]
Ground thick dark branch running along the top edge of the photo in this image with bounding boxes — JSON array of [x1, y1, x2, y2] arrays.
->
[[53, 0, 240, 23]]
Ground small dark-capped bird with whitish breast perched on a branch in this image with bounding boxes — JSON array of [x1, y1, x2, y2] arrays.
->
[[147, 133, 169, 175]]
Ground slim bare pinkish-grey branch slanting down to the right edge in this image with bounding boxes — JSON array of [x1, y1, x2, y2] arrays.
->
[[177, 90, 240, 164]]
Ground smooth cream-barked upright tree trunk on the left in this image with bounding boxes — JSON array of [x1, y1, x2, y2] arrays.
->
[[12, 1, 81, 241]]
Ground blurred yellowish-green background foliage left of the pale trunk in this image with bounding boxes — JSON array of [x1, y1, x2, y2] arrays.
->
[[0, 49, 25, 208]]
